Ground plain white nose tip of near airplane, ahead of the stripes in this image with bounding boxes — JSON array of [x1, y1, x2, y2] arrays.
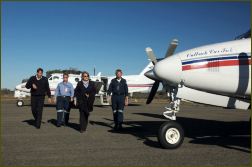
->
[[154, 55, 182, 84]]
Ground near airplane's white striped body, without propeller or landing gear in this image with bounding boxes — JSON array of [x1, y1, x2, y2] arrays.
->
[[154, 38, 251, 99]]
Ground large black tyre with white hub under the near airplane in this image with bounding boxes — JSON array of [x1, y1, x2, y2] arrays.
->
[[158, 121, 184, 149]]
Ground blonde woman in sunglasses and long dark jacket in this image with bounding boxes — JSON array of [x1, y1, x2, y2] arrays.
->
[[74, 71, 96, 133]]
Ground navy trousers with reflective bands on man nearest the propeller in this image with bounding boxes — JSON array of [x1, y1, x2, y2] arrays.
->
[[112, 95, 125, 125]]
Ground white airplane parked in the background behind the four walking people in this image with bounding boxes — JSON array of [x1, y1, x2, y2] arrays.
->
[[14, 62, 158, 107]]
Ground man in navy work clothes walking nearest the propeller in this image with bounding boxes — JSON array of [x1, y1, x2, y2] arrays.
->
[[108, 69, 128, 130]]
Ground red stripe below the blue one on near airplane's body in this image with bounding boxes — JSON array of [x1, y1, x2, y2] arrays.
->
[[182, 59, 251, 71]]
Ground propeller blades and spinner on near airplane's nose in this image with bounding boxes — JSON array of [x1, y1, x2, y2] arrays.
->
[[144, 39, 178, 104]]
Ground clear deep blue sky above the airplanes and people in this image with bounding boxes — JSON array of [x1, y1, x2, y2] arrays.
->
[[1, 2, 250, 90]]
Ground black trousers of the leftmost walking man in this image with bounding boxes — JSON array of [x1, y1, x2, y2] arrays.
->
[[31, 96, 45, 128]]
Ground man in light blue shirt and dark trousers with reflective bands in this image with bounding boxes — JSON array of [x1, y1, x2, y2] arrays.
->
[[55, 73, 74, 127]]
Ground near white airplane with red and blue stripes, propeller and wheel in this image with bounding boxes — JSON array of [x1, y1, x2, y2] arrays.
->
[[145, 31, 251, 149]]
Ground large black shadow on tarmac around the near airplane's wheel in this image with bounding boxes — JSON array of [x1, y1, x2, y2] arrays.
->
[[90, 113, 251, 153]]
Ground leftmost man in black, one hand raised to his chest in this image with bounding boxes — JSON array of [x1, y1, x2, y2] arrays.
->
[[25, 68, 51, 129]]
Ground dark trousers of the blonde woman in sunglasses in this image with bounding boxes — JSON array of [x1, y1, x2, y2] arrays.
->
[[79, 101, 89, 131]]
